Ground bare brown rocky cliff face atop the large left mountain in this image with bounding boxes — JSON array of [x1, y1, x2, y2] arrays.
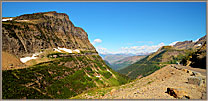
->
[[2, 12, 96, 57]]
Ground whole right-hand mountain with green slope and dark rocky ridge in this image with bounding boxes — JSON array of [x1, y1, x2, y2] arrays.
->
[[118, 36, 206, 79]]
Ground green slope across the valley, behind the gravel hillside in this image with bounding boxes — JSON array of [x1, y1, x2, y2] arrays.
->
[[118, 47, 192, 79]]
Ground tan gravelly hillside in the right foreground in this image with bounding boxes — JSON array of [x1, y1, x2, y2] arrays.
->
[[72, 65, 206, 99]]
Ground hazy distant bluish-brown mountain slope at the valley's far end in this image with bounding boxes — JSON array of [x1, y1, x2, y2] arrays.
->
[[110, 55, 145, 71]]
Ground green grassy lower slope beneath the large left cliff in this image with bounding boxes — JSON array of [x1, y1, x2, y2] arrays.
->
[[2, 55, 127, 99]]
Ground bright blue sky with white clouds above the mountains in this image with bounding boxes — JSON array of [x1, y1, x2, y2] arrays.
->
[[2, 2, 206, 54]]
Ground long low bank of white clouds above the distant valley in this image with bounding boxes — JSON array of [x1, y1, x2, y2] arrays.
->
[[96, 43, 165, 54]]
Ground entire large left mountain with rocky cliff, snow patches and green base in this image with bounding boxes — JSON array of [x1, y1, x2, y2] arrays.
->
[[2, 11, 128, 99]]
